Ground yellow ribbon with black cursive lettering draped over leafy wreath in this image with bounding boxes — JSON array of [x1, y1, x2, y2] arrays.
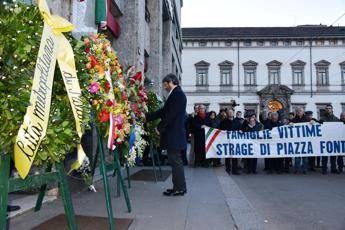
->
[[14, 0, 86, 178]]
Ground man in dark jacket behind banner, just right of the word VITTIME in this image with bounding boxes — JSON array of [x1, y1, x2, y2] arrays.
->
[[320, 105, 341, 174]]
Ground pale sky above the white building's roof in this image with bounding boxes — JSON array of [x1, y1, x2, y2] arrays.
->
[[181, 0, 345, 27]]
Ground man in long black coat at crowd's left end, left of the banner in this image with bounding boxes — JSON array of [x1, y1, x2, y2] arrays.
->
[[191, 105, 209, 167]]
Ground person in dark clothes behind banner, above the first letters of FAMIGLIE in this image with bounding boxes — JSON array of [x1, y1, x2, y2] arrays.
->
[[219, 109, 240, 175]]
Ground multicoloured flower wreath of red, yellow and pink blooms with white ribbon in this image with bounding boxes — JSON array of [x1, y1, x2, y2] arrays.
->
[[83, 34, 131, 171]]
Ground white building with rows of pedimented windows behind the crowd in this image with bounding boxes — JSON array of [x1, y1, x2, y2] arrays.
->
[[182, 25, 345, 117]]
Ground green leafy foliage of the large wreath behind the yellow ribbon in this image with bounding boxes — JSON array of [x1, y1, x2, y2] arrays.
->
[[0, 3, 89, 164]]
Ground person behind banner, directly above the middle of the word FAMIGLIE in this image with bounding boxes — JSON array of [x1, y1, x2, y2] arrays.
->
[[242, 114, 264, 174]]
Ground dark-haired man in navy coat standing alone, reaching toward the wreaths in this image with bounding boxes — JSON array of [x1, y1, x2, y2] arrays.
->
[[146, 74, 187, 196]]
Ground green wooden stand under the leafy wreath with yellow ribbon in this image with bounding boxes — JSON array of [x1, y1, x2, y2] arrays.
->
[[0, 154, 78, 230]]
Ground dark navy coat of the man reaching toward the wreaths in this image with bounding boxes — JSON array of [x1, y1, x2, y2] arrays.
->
[[146, 86, 187, 150]]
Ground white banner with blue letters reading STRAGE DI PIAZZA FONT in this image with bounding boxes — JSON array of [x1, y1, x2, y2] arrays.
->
[[205, 122, 345, 158]]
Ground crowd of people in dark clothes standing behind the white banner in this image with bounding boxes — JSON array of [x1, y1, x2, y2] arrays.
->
[[185, 105, 345, 175]]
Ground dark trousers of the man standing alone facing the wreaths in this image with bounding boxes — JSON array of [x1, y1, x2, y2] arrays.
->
[[168, 150, 186, 191]]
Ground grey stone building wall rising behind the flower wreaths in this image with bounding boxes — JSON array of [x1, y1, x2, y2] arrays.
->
[[70, 0, 183, 93]]
